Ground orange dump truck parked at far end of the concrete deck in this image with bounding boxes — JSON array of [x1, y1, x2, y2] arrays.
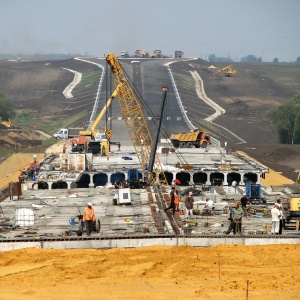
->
[[170, 129, 211, 148]]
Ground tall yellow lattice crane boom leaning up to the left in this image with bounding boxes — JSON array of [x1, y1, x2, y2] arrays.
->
[[106, 53, 168, 185]]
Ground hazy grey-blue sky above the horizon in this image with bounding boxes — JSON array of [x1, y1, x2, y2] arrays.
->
[[0, 0, 300, 61]]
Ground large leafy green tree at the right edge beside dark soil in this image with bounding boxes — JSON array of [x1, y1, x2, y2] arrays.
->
[[268, 94, 300, 144]]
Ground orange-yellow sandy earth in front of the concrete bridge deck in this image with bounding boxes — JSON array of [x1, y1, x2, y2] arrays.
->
[[0, 245, 300, 300]]
